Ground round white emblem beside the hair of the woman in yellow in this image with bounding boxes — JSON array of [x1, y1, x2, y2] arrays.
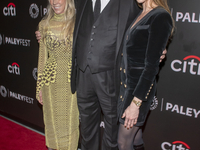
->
[[29, 3, 47, 19]]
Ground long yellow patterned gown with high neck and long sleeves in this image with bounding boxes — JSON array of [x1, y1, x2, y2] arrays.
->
[[36, 14, 79, 150]]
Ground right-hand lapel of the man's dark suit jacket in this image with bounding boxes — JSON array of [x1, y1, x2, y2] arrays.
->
[[115, 0, 132, 58]]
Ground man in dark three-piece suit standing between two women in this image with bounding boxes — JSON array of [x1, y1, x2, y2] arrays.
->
[[71, 0, 139, 150]]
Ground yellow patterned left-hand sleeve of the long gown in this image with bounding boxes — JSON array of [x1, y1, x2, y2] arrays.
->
[[36, 21, 47, 100]]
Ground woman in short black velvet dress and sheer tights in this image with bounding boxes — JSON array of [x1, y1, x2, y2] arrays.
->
[[118, 0, 173, 150]]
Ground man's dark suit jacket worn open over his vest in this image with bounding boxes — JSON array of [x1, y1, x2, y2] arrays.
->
[[71, 0, 139, 93]]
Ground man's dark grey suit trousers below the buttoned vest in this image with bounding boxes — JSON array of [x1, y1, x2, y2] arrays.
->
[[77, 66, 118, 150]]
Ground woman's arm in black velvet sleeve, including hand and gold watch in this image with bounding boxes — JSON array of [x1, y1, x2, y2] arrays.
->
[[122, 13, 172, 128]]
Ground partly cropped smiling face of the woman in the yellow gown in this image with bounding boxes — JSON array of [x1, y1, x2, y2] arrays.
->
[[49, 0, 66, 14]]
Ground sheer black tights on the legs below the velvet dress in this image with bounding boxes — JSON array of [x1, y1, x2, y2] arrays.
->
[[118, 124, 143, 150]]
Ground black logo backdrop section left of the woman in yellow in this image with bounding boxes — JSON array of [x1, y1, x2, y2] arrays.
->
[[0, 0, 47, 127]]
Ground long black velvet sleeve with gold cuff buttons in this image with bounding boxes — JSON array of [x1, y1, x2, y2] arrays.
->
[[133, 12, 172, 101]]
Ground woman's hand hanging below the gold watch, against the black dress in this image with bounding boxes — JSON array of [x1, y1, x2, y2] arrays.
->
[[122, 97, 142, 129]]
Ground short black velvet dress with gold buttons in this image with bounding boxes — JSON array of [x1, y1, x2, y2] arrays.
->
[[118, 7, 172, 126]]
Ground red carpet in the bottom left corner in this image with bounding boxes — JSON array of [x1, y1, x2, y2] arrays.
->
[[0, 116, 47, 150]]
